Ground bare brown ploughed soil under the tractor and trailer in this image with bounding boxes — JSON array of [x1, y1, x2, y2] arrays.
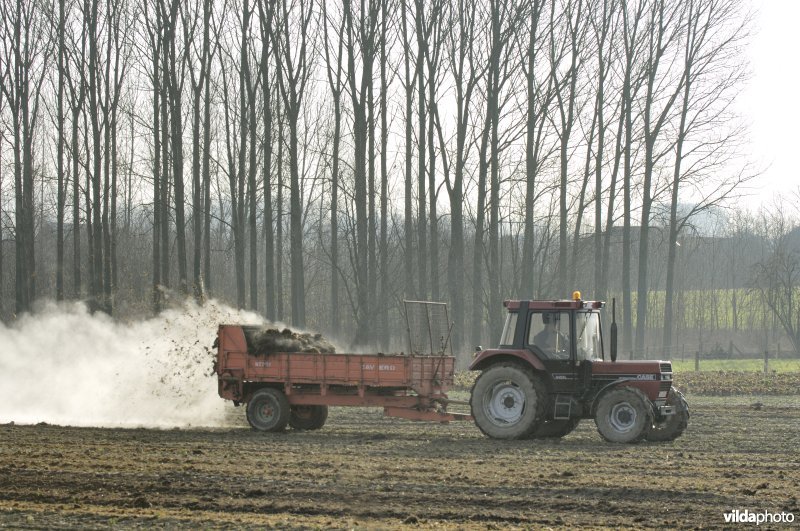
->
[[0, 399, 800, 529]]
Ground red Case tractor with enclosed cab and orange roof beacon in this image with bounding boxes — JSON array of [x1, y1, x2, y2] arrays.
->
[[470, 292, 689, 443]]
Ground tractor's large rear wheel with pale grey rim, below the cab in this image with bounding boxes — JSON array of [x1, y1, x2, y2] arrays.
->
[[470, 363, 545, 439]]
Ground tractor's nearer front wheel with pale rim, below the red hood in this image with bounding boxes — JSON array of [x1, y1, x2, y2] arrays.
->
[[594, 387, 653, 443]]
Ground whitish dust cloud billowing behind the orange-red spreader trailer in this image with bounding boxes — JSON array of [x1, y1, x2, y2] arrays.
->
[[0, 301, 263, 428]]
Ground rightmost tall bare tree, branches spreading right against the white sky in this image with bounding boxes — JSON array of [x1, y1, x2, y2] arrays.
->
[[663, 0, 749, 352]]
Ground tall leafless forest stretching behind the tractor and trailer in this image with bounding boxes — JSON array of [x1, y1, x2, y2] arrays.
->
[[0, 0, 800, 362]]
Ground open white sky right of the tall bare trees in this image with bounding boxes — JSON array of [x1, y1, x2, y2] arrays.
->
[[739, 0, 800, 209]]
